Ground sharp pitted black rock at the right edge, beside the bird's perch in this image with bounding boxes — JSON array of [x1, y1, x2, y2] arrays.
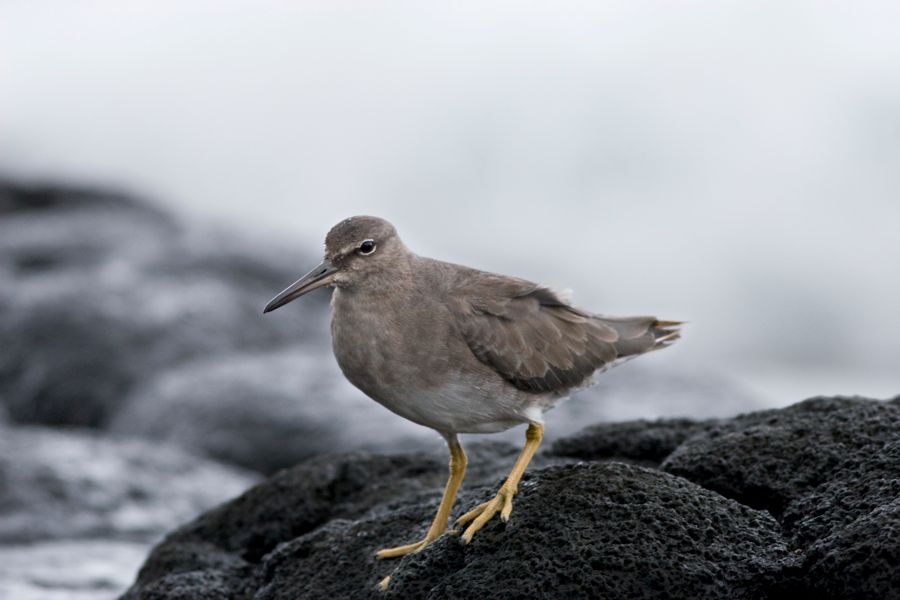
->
[[663, 398, 900, 599]]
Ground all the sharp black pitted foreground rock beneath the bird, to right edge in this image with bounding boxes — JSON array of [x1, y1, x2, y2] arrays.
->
[[125, 398, 900, 600]]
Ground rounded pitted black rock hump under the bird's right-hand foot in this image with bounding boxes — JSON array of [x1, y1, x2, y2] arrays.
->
[[376, 463, 794, 598]]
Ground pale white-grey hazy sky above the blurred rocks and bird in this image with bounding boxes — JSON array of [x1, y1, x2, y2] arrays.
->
[[0, 0, 900, 403]]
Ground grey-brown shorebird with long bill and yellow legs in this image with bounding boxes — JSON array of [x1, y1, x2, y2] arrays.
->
[[263, 216, 683, 559]]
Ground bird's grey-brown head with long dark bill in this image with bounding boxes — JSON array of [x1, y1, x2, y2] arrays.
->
[[263, 216, 408, 313]]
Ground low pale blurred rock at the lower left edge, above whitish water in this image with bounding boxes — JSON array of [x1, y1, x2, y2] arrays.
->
[[0, 427, 254, 544]]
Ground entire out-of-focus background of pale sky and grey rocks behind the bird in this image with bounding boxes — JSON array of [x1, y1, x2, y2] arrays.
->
[[0, 0, 900, 599]]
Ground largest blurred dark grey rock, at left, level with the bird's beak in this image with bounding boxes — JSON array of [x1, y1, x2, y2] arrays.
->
[[0, 182, 327, 427]]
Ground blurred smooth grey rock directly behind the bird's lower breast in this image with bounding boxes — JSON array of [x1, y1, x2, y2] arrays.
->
[[111, 346, 444, 473]]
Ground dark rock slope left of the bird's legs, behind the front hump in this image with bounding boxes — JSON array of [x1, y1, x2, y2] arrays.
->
[[127, 454, 445, 598]]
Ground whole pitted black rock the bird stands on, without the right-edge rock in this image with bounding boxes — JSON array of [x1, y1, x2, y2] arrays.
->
[[128, 455, 793, 599]]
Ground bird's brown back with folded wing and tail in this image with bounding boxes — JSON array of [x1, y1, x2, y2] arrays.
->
[[426, 259, 681, 393]]
